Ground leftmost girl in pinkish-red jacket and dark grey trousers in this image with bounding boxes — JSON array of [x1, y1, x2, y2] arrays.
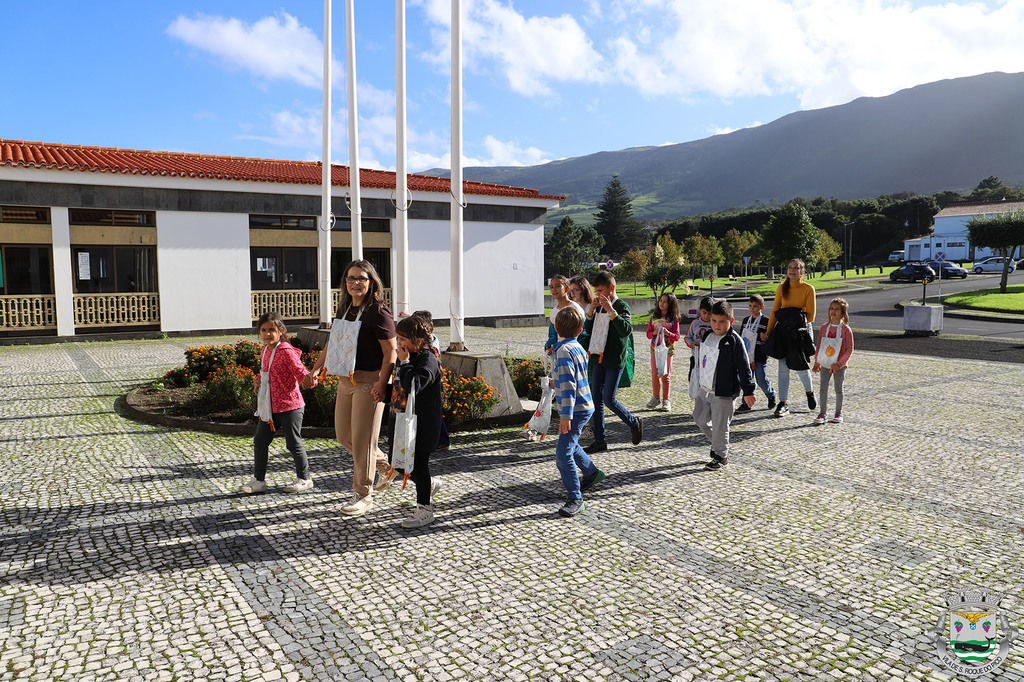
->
[[239, 312, 316, 495]]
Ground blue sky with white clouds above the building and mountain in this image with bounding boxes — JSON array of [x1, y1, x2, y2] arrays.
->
[[0, 0, 1024, 170]]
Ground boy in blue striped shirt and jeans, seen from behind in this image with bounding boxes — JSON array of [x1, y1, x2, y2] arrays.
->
[[552, 306, 604, 516]]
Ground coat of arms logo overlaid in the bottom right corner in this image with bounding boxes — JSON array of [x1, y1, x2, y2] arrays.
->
[[928, 588, 1017, 677]]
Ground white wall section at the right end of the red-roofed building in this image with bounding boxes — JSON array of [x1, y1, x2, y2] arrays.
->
[[409, 220, 544, 318]]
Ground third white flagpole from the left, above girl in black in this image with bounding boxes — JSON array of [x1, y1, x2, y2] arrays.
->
[[394, 0, 413, 313]]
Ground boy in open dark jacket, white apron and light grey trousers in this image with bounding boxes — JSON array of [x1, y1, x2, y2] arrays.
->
[[693, 301, 756, 471]]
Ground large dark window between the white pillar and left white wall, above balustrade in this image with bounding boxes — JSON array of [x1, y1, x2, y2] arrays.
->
[[72, 247, 157, 294]]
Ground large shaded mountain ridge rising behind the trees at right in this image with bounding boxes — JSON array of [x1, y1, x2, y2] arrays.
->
[[427, 73, 1024, 223]]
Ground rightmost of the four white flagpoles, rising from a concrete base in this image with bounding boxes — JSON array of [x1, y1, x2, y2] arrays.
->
[[449, 0, 466, 350]]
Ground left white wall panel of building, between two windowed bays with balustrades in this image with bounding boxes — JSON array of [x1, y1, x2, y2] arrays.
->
[[157, 211, 252, 332]]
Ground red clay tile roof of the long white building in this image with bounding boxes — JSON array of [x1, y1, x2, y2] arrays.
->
[[0, 139, 565, 201]]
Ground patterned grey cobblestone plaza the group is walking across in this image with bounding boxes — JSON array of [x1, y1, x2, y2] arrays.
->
[[0, 328, 1024, 681]]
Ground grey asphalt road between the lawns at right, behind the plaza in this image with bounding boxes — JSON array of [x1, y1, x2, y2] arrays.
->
[[827, 271, 1024, 341]]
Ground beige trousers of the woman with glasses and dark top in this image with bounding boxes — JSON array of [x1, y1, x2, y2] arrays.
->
[[334, 370, 390, 498]]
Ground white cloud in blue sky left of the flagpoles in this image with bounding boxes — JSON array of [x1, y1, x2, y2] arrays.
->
[[167, 12, 331, 87]]
